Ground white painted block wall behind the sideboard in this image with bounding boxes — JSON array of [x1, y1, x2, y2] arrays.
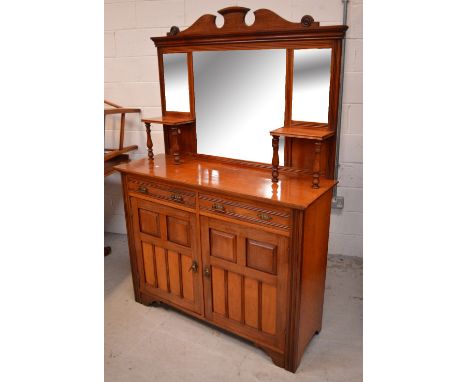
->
[[104, 0, 363, 257]]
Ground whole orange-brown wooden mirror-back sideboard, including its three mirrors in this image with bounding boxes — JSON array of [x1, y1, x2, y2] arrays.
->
[[116, 7, 347, 372]]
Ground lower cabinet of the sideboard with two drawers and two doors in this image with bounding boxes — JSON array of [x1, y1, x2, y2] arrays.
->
[[116, 154, 336, 371]]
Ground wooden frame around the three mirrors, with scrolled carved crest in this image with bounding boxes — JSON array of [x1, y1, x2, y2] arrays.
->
[[152, 7, 348, 182]]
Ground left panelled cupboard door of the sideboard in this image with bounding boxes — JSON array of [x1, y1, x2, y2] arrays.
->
[[131, 197, 203, 314]]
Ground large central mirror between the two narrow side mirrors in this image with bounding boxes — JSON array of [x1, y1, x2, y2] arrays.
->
[[193, 49, 286, 165]]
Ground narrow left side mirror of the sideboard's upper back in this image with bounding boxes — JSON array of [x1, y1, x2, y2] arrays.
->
[[163, 53, 190, 112]]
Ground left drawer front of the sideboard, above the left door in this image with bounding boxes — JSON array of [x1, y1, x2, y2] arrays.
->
[[127, 178, 195, 209]]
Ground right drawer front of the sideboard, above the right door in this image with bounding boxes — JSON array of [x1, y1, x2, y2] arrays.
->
[[199, 194, 291, 231]]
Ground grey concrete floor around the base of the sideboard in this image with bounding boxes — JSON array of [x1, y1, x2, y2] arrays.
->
[[104, 234, 362, 382]]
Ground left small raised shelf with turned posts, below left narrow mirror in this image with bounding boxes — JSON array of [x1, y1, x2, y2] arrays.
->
[[141, 113, 195, 164]]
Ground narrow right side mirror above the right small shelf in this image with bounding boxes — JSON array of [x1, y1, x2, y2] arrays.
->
[[292, 49, 331, 123]]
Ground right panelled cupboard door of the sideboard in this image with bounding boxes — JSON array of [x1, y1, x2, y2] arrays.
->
[[201, 216, 288, 350]]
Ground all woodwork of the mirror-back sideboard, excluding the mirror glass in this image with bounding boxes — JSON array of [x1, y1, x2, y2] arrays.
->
[[116, 7, 347, 372]]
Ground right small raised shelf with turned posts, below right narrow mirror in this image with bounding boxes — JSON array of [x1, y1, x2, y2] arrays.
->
[[270, 121, 335, 188]]
